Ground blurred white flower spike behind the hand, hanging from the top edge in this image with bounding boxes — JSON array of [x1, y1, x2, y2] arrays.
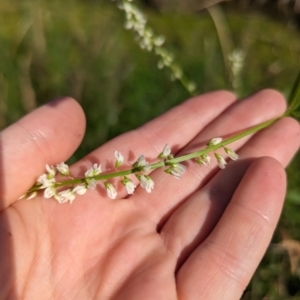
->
[[118, 0, 196, 93]]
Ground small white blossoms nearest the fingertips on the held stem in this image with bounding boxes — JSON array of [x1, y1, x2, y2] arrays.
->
[[195, 138, 239, 169]]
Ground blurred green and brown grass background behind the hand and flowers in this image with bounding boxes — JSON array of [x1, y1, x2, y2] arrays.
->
[[0, 0, 300, 300]]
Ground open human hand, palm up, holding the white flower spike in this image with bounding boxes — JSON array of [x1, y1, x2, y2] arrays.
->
[[0, 90, 300, 300]]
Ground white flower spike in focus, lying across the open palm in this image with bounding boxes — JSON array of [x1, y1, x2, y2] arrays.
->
[[20, 138, 238, 203]]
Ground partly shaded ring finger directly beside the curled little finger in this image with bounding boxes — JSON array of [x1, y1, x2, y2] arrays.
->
[[161, 118, 300, 266]]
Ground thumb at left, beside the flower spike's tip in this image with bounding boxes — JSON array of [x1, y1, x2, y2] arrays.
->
[[0, 98, 85, 209]]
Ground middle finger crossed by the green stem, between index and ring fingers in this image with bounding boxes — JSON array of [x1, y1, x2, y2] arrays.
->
[[131, 90, 285, 224]]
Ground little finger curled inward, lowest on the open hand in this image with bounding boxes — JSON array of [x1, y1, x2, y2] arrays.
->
[[177, 158, 285, 300]]
